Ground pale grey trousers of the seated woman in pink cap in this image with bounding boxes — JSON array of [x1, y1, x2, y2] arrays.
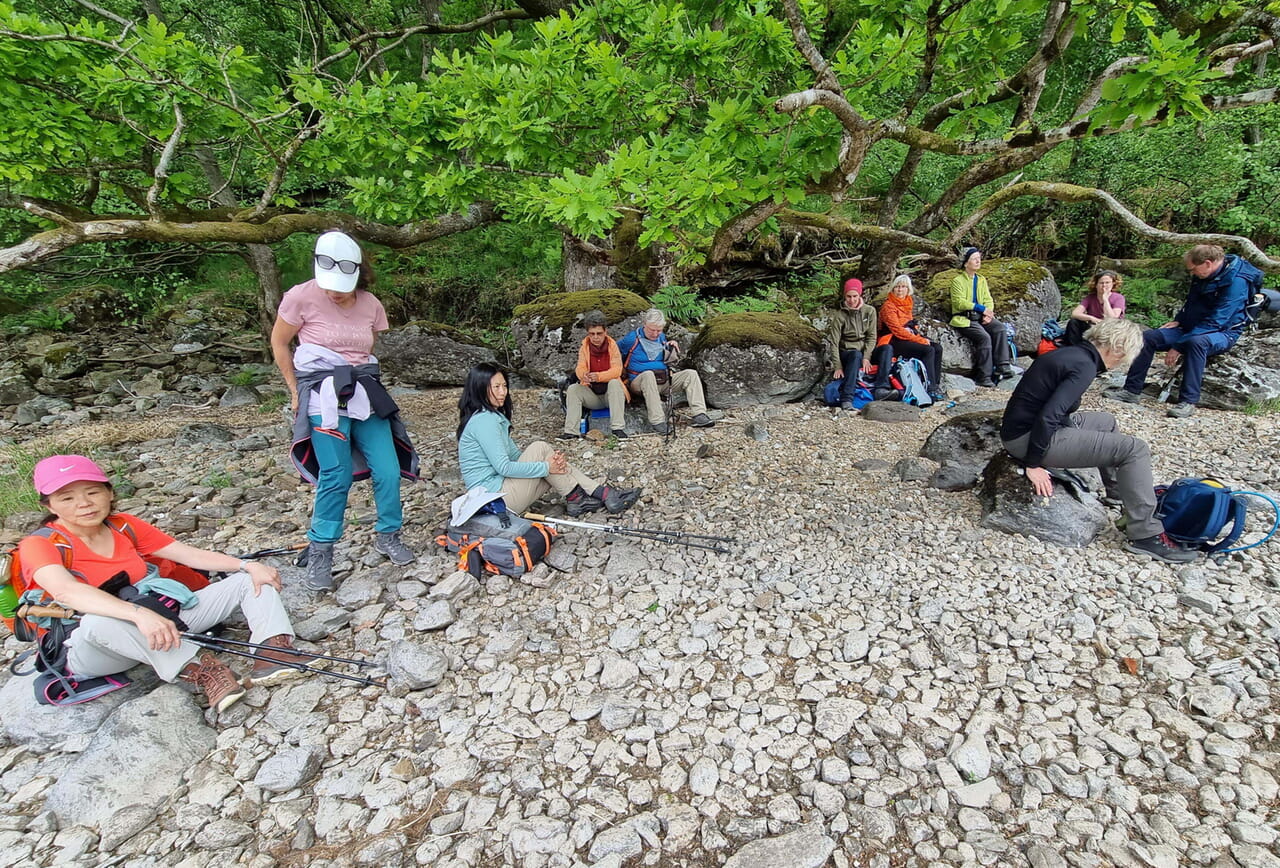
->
[[67, 572, 293, 681]]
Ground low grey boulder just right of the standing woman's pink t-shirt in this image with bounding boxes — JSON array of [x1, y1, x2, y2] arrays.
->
[[374, 321, 498, 388]]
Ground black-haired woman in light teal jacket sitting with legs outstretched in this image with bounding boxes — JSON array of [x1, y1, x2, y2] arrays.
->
[[458, 362, 640, 516]]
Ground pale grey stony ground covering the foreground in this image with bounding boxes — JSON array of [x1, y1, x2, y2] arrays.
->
[[0, 378, 1280, 868]]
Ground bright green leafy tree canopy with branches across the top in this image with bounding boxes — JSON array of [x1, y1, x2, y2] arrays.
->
[[0, 0, 1280, 311]]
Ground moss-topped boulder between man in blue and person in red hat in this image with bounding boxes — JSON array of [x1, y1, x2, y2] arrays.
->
[[689, 314, 827, 408]]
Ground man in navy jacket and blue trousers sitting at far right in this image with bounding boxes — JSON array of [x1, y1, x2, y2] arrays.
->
[[1106, 245, 1262, 419]]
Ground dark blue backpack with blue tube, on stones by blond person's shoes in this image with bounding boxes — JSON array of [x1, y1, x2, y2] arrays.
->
[[1156, 478, 1280, 554]]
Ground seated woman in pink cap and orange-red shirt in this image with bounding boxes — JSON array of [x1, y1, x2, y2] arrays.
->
[[18, 454, 306, 712]]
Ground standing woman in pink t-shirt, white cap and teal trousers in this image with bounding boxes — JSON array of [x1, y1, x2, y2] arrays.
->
[[271, 232, 417, 590]]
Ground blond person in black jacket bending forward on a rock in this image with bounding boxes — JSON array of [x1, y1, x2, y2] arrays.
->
[[1000, 319, 1198, 563]]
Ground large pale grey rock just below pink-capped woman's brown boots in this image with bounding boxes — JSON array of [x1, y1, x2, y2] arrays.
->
[[46, 685, 218, 828]]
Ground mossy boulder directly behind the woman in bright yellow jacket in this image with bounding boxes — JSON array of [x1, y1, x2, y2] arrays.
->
[[915, 259, 1062, 370]]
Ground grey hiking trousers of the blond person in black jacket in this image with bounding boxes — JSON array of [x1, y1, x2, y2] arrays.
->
[[1005, 411, 1165, 539]]
